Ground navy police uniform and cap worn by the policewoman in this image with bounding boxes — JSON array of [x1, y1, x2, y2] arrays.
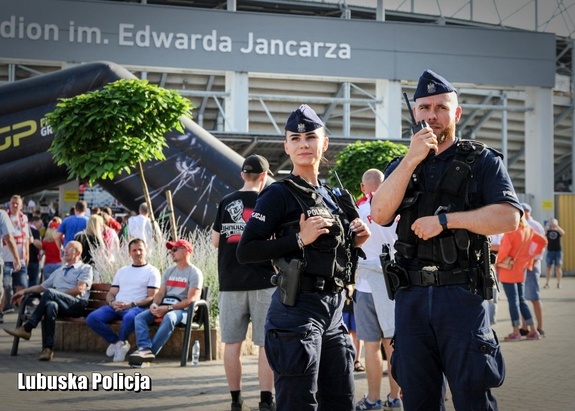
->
[[237, 105, 355, 411]]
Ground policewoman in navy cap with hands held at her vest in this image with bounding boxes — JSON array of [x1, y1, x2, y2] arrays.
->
[[237, 104, 370, 411]]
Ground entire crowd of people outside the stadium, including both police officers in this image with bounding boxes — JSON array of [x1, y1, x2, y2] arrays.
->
[[0, 70, 565, 411]]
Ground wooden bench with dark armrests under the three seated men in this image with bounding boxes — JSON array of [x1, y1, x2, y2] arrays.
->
[[10, 284, 212, 367]]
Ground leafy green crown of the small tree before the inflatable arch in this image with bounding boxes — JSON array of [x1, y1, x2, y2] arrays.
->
[[46, 79, 192, 184]]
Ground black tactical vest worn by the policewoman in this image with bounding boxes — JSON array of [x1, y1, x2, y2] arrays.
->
[[275, 176, 353, 283]]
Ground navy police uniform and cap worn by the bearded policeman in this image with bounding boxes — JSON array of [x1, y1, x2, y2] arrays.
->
[[385, 70, 521, 410]]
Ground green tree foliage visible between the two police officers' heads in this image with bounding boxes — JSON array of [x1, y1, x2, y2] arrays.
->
[[330, 140, 407, 198]]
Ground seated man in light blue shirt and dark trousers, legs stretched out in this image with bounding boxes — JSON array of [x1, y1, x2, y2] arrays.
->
[[4, 241, 93, 361]]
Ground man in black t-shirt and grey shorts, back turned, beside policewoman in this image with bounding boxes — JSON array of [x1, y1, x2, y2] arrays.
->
[[212, 155, 275, 411]]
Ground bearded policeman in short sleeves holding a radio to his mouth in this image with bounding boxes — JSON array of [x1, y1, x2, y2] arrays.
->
[[371, 70, 522, 411]]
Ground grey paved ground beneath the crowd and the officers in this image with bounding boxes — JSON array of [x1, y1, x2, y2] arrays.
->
[[0, 277, 575, 411]]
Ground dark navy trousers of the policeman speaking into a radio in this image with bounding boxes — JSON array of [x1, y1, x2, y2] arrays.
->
[[391, 285, 505, 411]]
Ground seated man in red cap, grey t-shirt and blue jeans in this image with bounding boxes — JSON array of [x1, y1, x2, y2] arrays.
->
[[128, 240, 204, 366]]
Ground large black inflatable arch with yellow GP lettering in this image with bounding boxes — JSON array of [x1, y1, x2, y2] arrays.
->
[[0, 62, 270, 230]]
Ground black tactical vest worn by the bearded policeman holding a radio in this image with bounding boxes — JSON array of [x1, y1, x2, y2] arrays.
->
[[395, 140, 486, 270]]
